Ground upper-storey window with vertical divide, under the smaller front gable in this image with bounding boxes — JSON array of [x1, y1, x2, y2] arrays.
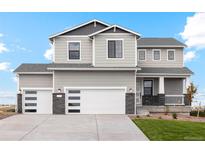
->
[[108, 40, 123, 58]]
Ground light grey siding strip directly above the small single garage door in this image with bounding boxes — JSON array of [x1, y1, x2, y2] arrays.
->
[[19, 74, 53, 88]]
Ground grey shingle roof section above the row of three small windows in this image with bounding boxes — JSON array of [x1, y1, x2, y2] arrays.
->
[[137, 38, 186, 47]]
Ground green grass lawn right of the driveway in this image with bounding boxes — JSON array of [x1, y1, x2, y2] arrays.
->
[[133, 119, 205, 141]]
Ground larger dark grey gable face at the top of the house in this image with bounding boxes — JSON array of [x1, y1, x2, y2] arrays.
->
[[62, 22, 108, 35]]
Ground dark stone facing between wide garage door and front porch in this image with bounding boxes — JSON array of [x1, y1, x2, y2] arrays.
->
[[125, 93, 135, 114]]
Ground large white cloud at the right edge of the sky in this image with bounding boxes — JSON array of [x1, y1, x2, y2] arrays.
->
[[180, 13, 205, 50]]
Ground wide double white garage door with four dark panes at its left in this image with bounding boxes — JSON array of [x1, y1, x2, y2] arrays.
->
[[66, 88, 125, 114]]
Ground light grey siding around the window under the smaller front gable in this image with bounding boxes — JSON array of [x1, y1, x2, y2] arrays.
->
[[95, 33, 135, 67]]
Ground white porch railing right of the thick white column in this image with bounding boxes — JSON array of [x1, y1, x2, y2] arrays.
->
[[165, 95, 184, 105]]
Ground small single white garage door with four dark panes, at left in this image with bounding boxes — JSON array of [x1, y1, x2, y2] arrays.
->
[[23, 89, 52, 114]]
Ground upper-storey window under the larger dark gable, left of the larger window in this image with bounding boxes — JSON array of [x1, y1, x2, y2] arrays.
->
[[68, 42, 80, 60]]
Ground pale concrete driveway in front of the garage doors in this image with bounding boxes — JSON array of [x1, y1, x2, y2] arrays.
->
[[0, 115, 148, 141]]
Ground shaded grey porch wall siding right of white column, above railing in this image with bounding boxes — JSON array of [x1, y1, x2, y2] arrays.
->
[[164, 78, 183, 95]]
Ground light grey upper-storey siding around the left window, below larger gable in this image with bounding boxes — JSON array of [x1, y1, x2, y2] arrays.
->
[[55, 37, 92, 63]]
